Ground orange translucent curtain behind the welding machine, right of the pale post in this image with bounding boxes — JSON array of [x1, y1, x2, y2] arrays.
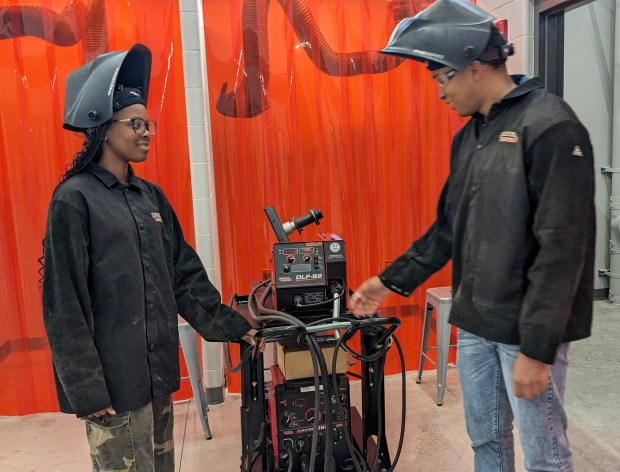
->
[[203, 0, 463, 390]]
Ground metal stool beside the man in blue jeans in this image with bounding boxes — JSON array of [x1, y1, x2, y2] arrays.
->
[[416, 287, 455, 406]]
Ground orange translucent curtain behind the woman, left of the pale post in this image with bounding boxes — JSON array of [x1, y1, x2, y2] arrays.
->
[[0, 0, 194, 415]]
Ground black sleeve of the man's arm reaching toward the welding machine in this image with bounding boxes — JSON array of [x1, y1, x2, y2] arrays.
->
[[379, 179, 452, 296]]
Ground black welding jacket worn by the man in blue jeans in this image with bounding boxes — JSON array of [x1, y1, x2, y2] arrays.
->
[[380, 77, 595, 364]]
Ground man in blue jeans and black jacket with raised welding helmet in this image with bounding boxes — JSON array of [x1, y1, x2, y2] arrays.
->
[[350, 0, 595, 472]]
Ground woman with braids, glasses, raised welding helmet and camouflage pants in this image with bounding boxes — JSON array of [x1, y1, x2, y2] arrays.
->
[[43, 45, 254, 472]]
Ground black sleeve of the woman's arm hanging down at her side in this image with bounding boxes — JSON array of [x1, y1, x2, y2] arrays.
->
[[43, 201, 114, 417]]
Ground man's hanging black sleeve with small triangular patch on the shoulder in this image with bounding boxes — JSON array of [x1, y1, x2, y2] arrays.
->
[[519, 121, 594, 364]]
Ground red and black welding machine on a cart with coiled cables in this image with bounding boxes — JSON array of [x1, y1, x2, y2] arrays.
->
[[233, 207, 405, 472]]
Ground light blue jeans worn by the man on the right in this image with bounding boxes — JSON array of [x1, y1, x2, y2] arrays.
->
[[458, 329, 573, 472]]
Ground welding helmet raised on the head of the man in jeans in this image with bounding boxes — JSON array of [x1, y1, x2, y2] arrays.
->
[[381, 0, 513, 70]]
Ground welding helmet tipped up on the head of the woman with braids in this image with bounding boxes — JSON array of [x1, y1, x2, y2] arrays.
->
[[63, 44, 151, 131]]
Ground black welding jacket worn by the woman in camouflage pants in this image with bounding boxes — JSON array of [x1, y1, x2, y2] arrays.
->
[[43, 164, 250, 417]]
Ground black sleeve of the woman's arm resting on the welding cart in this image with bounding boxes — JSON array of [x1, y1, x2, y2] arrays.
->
[[170, 208, 251, 342]]
